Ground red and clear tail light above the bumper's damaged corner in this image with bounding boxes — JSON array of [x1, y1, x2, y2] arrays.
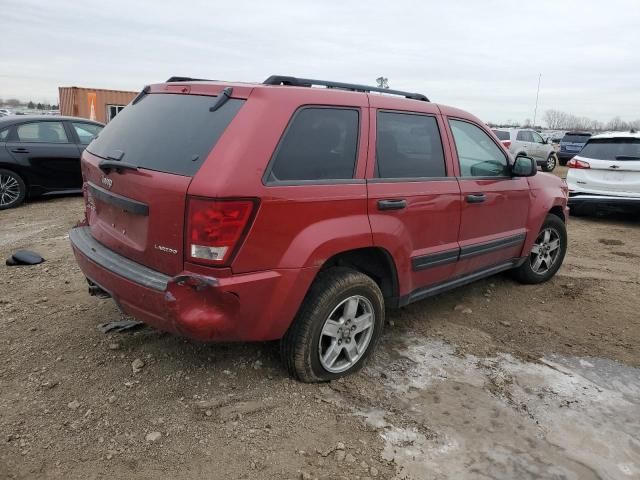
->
[[185, 197, 255, 266]]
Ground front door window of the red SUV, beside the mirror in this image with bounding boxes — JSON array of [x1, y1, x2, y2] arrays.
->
[[449, 120, 509, 177]]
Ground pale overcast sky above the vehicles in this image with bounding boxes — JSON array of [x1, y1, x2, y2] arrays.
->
[[0, 0, 640, 121]]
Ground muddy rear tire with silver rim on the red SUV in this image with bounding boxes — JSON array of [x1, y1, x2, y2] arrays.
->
[[280, 268, 385, 382]]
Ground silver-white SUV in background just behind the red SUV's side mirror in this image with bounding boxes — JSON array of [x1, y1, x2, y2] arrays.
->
[[493, 128, 558, 172]]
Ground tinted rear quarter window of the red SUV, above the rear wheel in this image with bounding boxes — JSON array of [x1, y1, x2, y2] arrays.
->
[[267, 107, 358, 183]]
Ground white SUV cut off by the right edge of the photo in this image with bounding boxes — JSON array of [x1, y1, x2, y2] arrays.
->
[[567, 132, 640, 215]]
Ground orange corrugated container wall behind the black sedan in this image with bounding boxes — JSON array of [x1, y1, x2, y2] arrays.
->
[[58, 87, 138, 123]]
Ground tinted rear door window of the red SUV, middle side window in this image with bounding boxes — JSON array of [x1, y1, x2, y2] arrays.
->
[[376, 112, 447, 178]]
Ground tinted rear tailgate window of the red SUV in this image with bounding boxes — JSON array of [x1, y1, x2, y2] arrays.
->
[[87, 94, 244, 177]]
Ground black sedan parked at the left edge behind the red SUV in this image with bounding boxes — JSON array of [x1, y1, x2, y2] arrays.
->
[[0, 115, 103, 210]]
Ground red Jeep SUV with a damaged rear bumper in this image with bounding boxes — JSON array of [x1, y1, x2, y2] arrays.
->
[[70, 76, 567, 381]]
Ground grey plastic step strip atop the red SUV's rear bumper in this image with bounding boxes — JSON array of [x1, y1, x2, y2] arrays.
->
[[69, 227, 171, 292]]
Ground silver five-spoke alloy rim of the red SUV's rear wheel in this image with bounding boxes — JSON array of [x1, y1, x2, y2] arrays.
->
[[318, 295, 375, 373]]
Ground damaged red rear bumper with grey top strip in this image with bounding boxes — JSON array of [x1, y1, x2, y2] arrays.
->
[[69, 227, 317, 341]]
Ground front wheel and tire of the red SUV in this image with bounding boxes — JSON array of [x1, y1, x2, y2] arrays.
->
[[513, 214, 567, 284]]
